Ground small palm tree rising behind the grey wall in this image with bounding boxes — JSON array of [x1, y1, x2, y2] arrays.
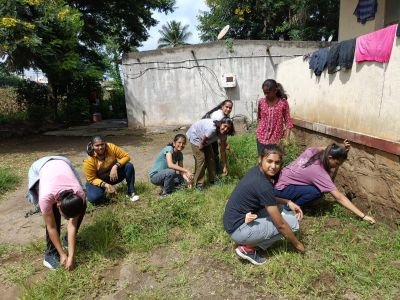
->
[[158, 21, 192, 48]]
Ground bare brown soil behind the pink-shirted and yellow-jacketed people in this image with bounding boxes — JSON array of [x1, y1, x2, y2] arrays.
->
[[0, 132, 194, 299]]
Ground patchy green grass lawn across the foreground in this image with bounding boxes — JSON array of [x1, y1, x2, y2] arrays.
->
[[0, 135, 400, 299]]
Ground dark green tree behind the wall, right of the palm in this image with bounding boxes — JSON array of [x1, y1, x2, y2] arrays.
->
[[198, 0, 339, 41]]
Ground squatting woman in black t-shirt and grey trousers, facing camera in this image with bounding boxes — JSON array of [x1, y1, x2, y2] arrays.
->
[[224, 145, 305, 265]]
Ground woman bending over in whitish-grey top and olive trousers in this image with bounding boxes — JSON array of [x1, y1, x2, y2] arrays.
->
[[186, 118, 235, 190]]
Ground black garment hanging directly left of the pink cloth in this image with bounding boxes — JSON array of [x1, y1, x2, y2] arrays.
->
[[327, 39, 356, 74]]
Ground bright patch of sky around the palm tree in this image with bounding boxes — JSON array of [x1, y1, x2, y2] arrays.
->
[[138, 0, 208, 51]]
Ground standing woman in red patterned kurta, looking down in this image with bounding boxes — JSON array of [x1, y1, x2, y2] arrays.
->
[[256, 79, 293, 155]]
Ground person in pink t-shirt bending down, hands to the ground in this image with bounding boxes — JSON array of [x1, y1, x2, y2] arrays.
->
[[27, 156, 86, 270]]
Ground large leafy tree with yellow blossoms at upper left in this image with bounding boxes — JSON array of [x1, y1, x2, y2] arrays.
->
[[0, 0, 175, 122]]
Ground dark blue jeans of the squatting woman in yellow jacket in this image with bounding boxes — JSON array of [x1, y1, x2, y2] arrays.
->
[[86, 162, 135, 204]]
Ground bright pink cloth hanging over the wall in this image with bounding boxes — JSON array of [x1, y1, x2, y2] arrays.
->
[[356, 24, 397, 63]]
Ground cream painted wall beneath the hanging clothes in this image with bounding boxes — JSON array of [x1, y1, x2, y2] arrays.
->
[[277, 38, 400, 142]]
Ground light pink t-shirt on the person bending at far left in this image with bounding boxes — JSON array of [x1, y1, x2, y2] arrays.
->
[[39, 159, 85, 215]]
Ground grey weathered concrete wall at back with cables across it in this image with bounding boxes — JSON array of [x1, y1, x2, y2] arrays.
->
[[123, 41, 320, 128]]
